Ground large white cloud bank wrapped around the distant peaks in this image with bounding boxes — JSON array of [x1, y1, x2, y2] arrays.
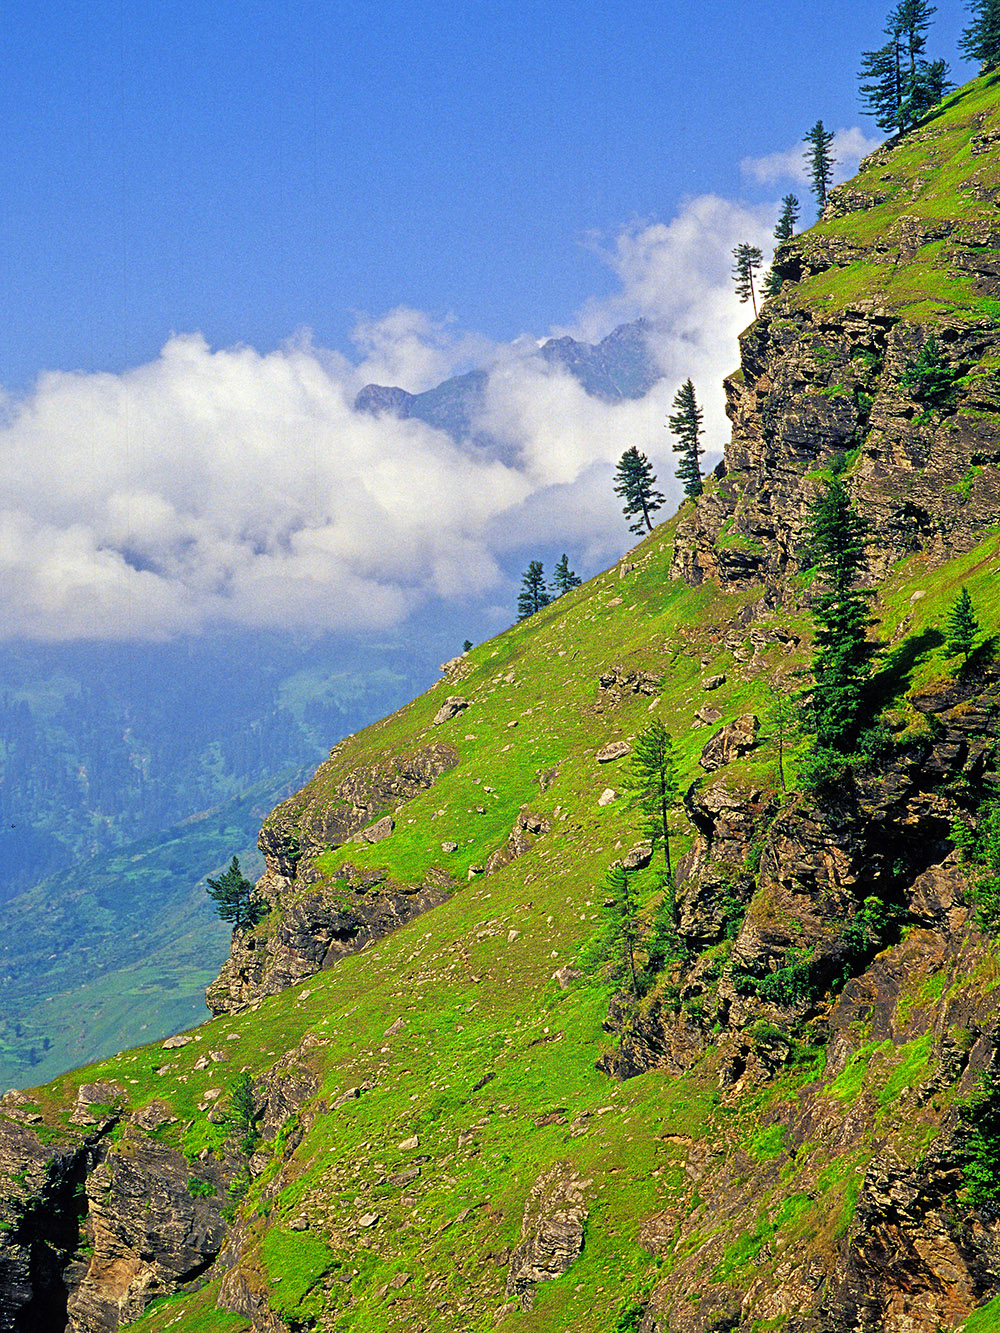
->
[[0, 196, 775, 640]]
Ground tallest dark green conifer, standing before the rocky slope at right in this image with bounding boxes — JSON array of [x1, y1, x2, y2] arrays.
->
[[809, 477, 873, 754]]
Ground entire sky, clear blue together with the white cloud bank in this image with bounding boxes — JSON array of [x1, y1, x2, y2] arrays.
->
[[0, 0, 973, 640]]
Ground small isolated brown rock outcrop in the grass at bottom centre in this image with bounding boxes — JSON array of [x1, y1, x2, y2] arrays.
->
[[507, 1164, 591, 1310]]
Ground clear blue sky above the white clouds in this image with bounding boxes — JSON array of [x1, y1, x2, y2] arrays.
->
[[0, 0, 981, 389]]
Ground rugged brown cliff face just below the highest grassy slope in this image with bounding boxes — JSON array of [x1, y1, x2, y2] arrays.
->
[[672, 273, 1000, 605]]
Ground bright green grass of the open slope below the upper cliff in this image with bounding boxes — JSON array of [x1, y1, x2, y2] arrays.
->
[[15, 503, 1000, 1333]]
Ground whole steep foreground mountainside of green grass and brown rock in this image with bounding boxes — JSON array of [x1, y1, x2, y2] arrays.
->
[[0, 80, 1000, 1333]]
